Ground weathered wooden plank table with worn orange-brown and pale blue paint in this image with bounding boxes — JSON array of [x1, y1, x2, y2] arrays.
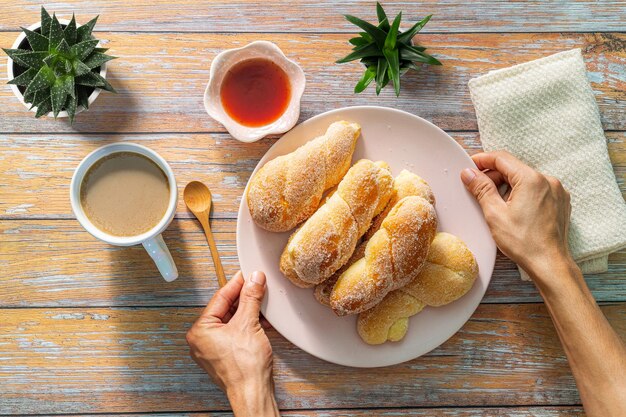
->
[[0, 0, 626, 417]]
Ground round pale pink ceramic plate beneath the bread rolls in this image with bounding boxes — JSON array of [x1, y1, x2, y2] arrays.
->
[[237, 107, 496, 367]]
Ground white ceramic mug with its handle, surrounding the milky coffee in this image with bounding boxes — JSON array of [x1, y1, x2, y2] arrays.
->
[[70, 142, 178, 282]]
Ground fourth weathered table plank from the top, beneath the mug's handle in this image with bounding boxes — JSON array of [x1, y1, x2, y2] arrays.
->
[[0, 219, 626, 306]]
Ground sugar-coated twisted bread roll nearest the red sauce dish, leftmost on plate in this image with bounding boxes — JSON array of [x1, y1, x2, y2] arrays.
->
[[246, 121, 361, 232]]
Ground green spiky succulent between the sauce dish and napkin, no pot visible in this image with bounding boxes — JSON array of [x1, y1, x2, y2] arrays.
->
[[337, 3, 441, 96]]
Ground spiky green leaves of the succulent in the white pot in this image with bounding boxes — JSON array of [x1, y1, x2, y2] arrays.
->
[[3, 7, 115, 123]]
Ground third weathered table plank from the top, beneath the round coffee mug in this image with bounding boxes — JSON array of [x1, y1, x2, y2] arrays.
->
[[0, 131, 626, 219]]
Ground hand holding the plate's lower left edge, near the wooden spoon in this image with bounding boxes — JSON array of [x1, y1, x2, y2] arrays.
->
[[187, 271, 278, 417]]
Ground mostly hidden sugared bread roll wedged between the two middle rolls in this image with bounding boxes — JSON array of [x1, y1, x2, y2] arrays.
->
[[314, 169, 435, 306]]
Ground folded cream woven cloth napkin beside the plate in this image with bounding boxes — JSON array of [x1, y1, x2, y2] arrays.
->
[[469, 49, 626, 279]]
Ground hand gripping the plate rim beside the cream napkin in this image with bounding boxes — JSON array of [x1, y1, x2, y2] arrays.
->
[[461, 151, 571, 278]]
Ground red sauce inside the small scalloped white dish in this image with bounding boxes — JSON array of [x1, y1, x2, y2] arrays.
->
[[220, 58, 291, 127]]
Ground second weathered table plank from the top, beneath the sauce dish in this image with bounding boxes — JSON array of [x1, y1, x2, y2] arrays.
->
[[0, 32, 626, 133]]
